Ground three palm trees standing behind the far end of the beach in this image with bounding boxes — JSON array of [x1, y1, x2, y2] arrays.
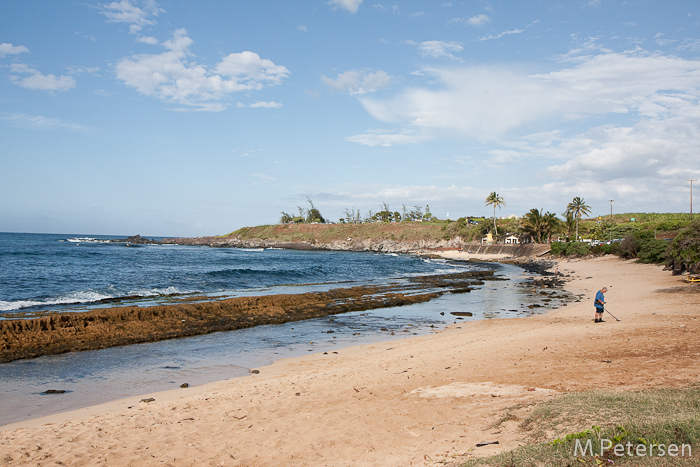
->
[[484, 191, 591, 243]]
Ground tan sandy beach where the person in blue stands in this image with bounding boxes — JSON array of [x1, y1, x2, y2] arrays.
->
[[0, 257, 700, 467]]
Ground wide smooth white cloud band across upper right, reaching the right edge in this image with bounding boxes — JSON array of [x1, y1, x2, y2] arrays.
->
[[360, 50, 700, 140]]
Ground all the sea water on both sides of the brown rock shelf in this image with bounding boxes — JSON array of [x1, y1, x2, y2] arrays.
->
[[0, 233, 564, 426]]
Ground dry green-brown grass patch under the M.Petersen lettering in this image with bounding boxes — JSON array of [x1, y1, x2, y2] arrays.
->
[[462, 386, 700, 467]]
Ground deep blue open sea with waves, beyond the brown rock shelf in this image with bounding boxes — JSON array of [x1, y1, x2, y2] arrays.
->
[[0, 233, 482, 312]]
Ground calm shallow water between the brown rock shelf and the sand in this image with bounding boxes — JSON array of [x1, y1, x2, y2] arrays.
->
[[0, 263, 563, 426]]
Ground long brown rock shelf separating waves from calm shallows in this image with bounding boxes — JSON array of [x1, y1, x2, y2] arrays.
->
[[0, 271, 499, 363]]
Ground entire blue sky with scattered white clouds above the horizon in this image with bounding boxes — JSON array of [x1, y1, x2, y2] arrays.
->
[[0, 0, 700, 236]]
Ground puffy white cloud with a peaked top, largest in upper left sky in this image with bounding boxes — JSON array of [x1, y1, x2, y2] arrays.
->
[[116, 29, 289, 111]]
